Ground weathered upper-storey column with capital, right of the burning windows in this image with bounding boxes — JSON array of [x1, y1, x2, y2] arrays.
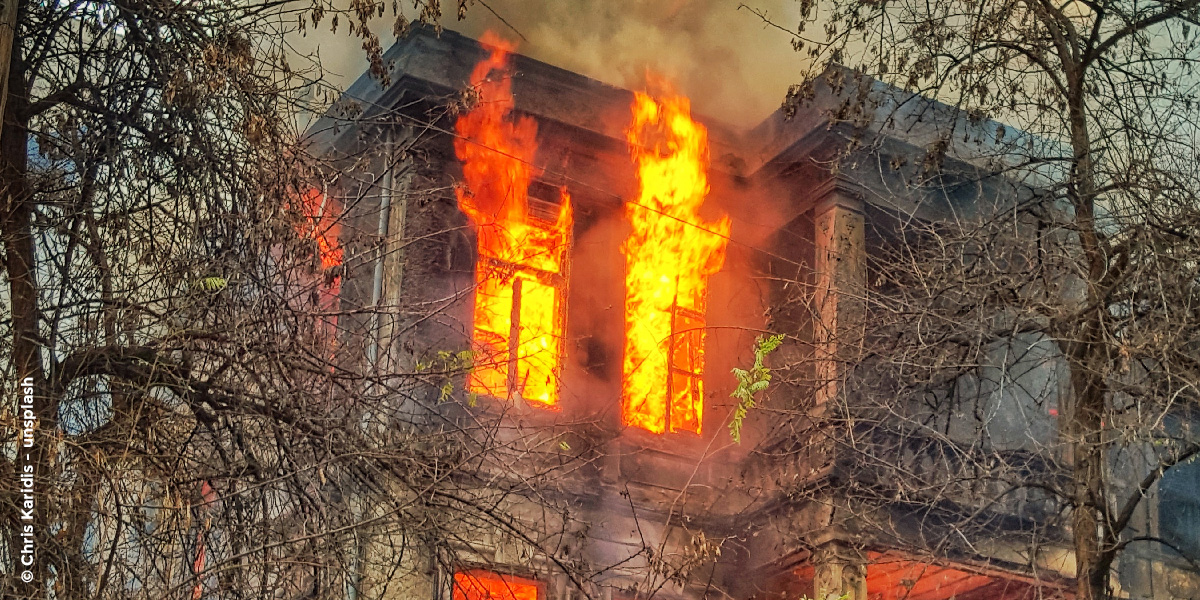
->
[[812, 187, 866, 407]]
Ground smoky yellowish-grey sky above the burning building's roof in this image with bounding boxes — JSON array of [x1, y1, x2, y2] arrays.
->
[[294, 0, 805, 127]]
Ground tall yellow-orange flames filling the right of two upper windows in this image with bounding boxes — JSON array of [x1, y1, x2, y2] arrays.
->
[[622, 84, 730, 433]]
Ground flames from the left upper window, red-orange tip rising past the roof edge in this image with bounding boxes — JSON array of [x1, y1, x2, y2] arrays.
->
[[455, 32, 571, 406]]
